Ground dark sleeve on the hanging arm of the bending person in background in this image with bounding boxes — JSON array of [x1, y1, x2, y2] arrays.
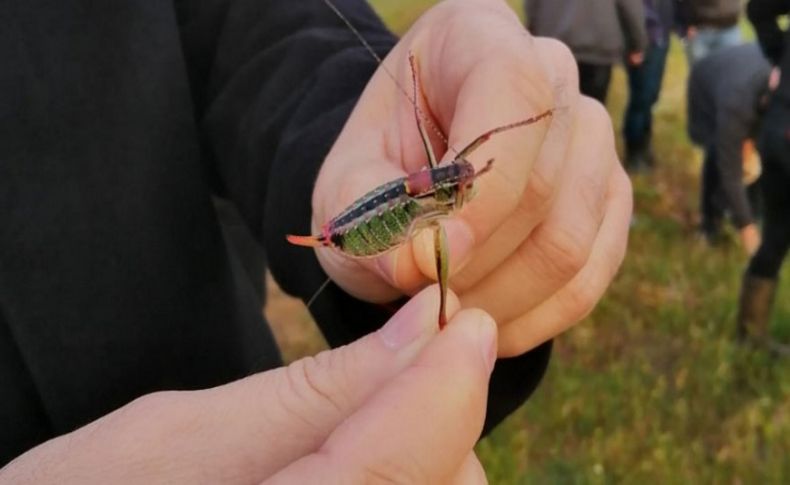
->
[[715, 97, 755, 229]]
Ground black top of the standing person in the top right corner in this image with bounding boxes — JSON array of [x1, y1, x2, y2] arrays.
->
[[748, 0, 790, 105]]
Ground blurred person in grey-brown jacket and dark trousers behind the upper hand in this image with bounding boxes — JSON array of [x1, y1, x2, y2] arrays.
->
[[524, 0, 648, 104]]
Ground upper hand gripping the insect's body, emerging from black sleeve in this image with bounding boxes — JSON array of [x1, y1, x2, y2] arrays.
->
[[313, 0, 631, 356]]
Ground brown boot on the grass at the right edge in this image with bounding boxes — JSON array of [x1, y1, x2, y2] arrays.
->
[[736, 273, 790, 355]]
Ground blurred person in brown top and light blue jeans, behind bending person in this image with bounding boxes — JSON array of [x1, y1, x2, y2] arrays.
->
[[676, 0, 743, 65]]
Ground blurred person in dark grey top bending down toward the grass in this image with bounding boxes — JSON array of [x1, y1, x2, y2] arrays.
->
[[688, 44, 771, 254]]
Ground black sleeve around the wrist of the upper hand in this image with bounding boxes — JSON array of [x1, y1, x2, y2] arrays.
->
[[177, 0, 551, 429]]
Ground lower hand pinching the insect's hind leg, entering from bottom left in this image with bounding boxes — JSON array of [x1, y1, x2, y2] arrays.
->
[[0, 286, 496, 484]]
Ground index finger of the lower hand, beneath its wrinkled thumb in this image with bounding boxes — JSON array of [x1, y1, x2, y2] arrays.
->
[[272, 310, 496, 483]]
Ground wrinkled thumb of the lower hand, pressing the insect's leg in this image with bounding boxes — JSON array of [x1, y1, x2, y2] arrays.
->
[[176, 286, 459, 480]]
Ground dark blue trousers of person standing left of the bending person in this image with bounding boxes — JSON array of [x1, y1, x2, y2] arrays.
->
[[623, 44, 669, 153]]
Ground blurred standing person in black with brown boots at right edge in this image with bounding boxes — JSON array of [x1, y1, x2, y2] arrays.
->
[[737, 0, 790, 355]]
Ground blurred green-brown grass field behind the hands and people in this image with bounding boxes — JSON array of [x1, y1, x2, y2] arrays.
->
[[267, 0, 790, 484]]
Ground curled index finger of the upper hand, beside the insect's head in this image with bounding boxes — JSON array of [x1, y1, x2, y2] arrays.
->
[[425, 1, 555, 244]]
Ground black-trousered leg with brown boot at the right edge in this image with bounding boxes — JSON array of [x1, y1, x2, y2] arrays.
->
[[737, 107, 790, 346]]
